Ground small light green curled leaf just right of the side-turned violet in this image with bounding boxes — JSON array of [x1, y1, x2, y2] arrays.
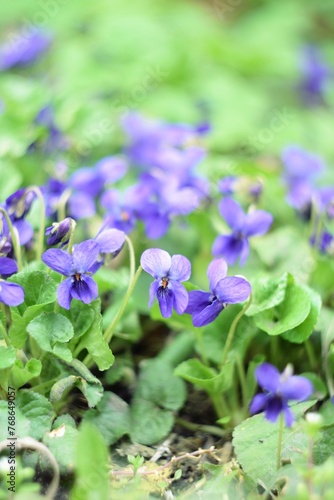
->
[[245, 273, 289, 316]]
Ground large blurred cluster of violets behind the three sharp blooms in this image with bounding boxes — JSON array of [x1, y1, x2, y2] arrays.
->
[[43, 113, 209, 239]]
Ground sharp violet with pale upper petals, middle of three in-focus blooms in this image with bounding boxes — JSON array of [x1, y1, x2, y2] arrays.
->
[[140, 248, 191, 318]]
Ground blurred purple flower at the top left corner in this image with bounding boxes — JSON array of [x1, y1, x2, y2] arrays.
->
[[0, 31, 51, 70]]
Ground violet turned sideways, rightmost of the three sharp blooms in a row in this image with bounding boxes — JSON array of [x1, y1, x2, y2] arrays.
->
[[185, 259, 252, 327]]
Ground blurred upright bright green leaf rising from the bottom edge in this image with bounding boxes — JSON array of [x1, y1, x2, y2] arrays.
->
[[71, 422, 110, 500]]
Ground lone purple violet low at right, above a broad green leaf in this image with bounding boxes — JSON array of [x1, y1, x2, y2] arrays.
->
[[249, 363, 313, 427]]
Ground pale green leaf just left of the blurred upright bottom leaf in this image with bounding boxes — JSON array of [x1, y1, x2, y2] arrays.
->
[[42, 415, 79, 474]]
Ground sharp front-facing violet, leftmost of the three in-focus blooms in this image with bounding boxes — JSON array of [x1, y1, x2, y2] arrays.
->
[[42, 240, 100, 309]]
